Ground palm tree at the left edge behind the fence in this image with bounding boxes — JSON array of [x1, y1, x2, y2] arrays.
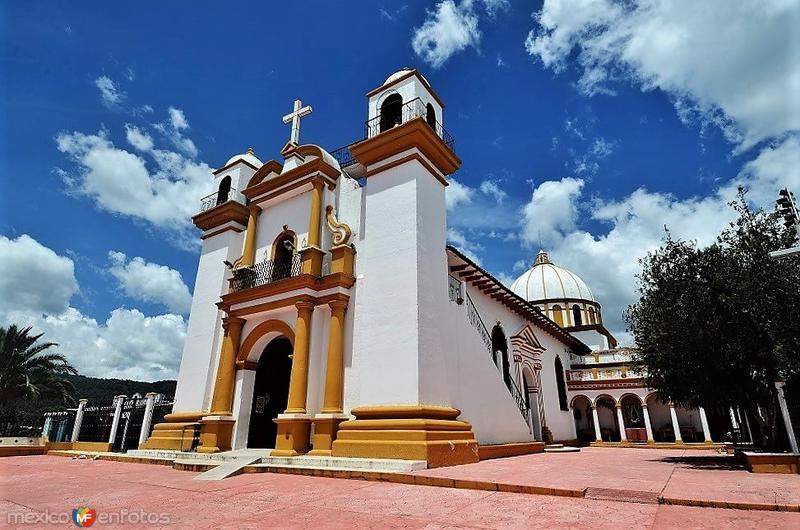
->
[[0, 324, 78, 408]]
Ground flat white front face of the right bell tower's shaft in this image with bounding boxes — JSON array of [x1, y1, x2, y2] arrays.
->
[[352, 162, 424, 405]]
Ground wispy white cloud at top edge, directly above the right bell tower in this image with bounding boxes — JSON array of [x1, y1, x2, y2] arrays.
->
[[411, 0, 481, 68]]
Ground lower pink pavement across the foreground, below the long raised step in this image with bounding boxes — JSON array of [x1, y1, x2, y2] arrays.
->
[[0, 455, 800, 529]]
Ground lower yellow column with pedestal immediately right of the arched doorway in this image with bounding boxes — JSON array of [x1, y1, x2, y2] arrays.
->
[[272, 300, 314, 456]]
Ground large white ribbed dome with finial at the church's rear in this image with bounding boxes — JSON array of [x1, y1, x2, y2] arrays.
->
[[511, 250, 597, 303]]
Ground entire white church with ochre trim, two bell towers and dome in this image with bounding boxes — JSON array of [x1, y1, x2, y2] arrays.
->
[[142, 68, 736, 467]]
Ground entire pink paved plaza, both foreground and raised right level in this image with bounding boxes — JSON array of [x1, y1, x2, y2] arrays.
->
[[0, 448, 800, 528]]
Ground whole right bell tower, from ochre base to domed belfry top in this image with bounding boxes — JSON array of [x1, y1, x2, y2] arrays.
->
[[333, 68, 476, 464]]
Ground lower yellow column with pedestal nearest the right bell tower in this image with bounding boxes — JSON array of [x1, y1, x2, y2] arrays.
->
[[309, 298, 348, 456]]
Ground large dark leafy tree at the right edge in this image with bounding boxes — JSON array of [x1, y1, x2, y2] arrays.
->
[[626, 190, 800, 449]]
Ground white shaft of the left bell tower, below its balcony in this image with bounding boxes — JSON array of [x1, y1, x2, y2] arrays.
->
[[173, 231, 242, 412]]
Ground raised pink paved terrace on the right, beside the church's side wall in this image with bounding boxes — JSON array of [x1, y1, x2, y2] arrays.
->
[[415, 447, 800, 508]]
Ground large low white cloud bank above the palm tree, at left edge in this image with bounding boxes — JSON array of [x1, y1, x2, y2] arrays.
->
[[0, 235, 186, 380]]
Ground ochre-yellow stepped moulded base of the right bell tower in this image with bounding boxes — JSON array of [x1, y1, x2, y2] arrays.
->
[[332, 405, 480, 468]]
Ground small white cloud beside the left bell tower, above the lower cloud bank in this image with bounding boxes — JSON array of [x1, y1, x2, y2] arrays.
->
[[108, 250, 192, 315]]
